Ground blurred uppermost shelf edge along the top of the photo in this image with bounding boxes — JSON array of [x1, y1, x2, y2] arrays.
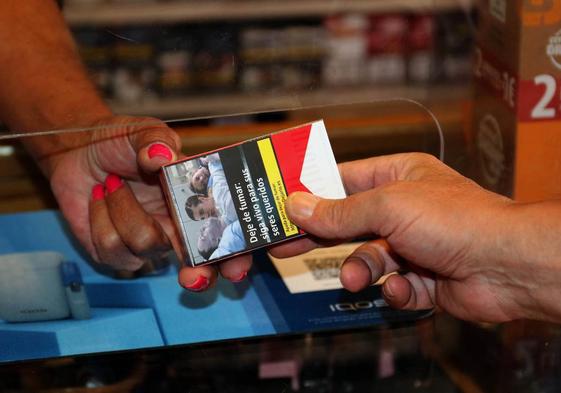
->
[[65, 0, 472, 26]]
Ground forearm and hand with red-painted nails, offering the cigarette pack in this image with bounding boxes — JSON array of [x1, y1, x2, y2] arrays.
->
[[0, 0, 249, 286]]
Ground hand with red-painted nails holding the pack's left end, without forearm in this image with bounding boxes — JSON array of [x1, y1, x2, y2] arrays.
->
[[43, 116, 251, 292]]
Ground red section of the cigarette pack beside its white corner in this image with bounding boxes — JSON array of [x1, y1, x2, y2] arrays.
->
[[271, 124, 312, 195]]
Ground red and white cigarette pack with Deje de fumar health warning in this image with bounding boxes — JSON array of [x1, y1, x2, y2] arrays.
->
[[161, 120, 346, 266]]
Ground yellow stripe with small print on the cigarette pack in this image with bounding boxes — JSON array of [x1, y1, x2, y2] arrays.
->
[[257, 138, 298, 236]]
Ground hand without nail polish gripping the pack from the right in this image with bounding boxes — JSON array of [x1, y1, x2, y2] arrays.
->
[[271, 154, 530, 321]]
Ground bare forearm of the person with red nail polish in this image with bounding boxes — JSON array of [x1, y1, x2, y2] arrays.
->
[[0, 0, 110, 172]]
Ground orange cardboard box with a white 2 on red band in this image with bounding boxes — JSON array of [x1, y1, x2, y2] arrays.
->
[[473, 0, 561, 201]]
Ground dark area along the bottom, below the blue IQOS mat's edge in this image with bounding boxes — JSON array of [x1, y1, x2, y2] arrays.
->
[[4, 314, 561, 393]]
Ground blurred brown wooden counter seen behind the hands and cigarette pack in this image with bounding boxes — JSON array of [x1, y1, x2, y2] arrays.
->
[[0, 92, 471, 213]]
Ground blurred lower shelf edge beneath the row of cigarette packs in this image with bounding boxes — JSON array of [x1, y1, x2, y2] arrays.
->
[[108, 84, 471, 119]]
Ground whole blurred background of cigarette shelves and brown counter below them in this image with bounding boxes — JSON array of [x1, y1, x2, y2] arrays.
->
[[0, 0, 477, 212]]
